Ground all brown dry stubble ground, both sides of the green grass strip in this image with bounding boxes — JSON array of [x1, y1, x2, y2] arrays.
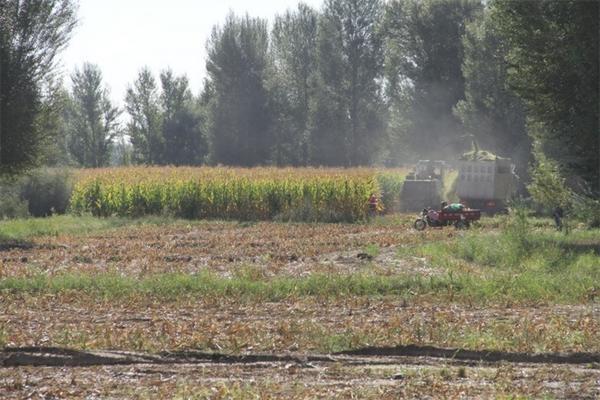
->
[[0, 222, 600, 399]]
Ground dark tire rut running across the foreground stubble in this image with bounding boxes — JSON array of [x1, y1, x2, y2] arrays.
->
[[0, 345, 600, 368]]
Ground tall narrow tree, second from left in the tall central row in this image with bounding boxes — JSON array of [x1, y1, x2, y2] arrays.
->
[[268, 3, 318, 165]]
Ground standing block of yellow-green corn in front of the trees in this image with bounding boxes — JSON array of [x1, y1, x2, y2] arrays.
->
[[70, 167, 404, 222]]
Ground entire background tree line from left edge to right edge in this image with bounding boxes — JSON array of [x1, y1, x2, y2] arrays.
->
[[0, 0, 600, 194]]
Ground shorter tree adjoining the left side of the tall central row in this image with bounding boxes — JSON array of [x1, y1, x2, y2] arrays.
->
[[160, 70, 207, 165]]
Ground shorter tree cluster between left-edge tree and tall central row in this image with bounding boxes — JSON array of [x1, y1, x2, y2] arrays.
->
[[55, 63, 208, 168]]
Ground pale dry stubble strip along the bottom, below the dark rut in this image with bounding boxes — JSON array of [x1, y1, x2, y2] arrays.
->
[[0, 353, 600, 399]]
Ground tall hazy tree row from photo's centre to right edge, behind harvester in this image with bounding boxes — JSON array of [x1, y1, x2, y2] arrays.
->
[[199, 0, 600, 194]]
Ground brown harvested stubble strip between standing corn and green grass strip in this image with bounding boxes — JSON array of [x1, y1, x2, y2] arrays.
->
[[1, 217, 438, 278]]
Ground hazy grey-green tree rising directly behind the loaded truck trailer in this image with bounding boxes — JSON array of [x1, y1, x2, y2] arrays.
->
[[455, 8, 531, 178]]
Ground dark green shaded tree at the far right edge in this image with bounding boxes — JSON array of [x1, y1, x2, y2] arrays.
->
[[491, 0, 600, 191]]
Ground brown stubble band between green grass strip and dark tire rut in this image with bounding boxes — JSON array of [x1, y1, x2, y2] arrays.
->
[[0, 294, 600, 353]]
